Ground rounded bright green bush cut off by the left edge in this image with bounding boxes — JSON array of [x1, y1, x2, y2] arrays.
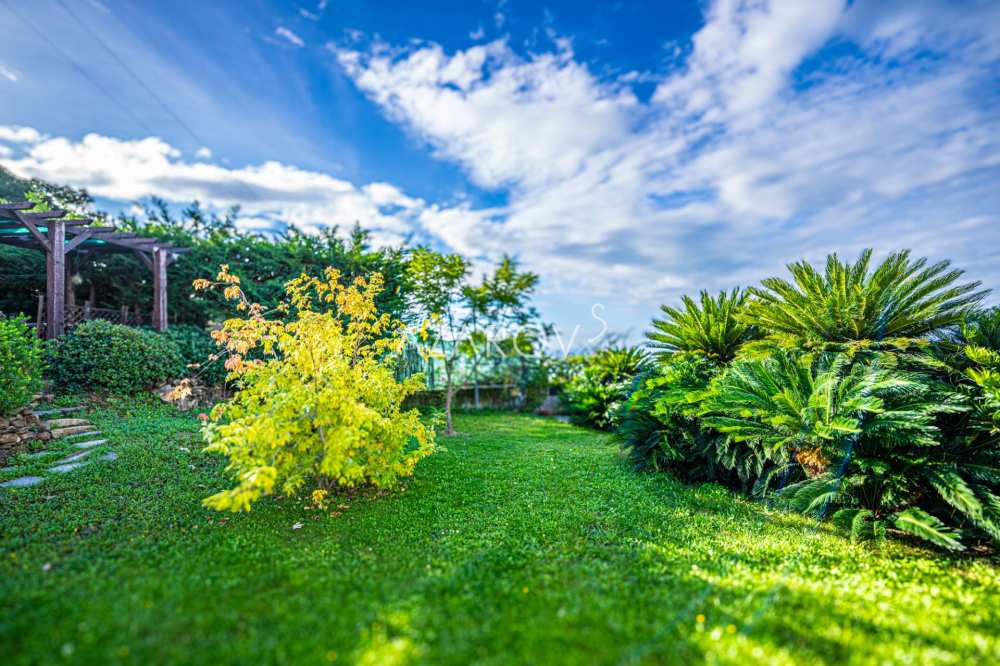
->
[[0, 317, 43, 416]]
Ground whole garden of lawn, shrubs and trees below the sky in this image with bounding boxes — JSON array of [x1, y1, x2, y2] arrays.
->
[[0, 183, 1000, 664]]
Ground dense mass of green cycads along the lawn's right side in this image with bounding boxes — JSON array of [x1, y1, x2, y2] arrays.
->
[[569, 251, 1000, 551]]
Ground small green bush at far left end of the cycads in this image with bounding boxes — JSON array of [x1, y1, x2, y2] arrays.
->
[[562, 347, 646, 430]]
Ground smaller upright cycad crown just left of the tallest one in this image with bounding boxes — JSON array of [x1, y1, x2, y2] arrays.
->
[[646, 289, 758, 364]]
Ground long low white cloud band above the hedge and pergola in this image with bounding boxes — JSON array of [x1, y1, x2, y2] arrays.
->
[[0, 125, 439, 243]]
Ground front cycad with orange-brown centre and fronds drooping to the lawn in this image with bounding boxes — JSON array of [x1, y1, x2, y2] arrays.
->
[[702, 352, 1000, 550]]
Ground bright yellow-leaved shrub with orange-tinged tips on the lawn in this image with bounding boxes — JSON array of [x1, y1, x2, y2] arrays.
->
[[194, 265, 434, 511]]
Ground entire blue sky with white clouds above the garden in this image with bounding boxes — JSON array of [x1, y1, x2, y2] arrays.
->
[[0, 0, 1000, 343]]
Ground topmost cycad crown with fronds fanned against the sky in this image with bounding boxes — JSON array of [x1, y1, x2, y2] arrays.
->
[[746, 250, 986, 346]]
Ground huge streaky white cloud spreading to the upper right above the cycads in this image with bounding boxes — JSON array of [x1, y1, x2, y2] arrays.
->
[[332, 0, 1000, 314]]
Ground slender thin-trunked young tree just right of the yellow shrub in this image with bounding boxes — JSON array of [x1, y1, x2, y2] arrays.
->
[[407, 247, 469, 435]]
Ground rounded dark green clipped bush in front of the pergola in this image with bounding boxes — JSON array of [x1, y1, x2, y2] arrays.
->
[[48, 319, 185, 394]]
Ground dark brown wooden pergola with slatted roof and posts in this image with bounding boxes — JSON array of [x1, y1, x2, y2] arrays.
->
[[0, 201, 189, 338]]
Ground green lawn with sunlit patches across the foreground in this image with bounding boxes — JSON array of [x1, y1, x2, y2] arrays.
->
[[0, 405, 1000, 664]]
